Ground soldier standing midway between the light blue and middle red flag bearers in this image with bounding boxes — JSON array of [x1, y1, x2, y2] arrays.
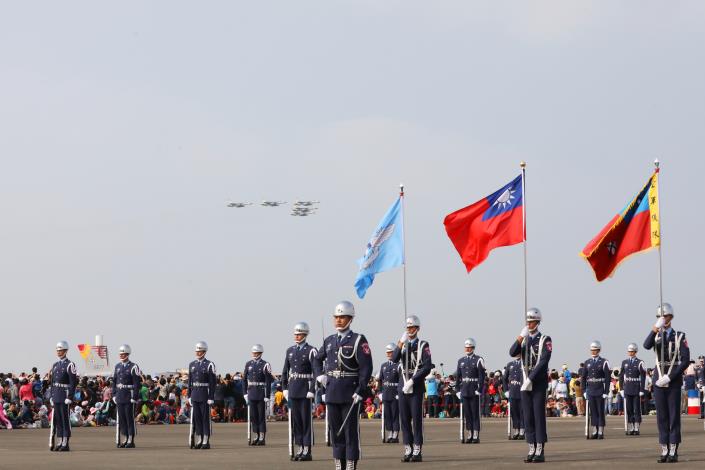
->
[[455, 338, 487, 444]]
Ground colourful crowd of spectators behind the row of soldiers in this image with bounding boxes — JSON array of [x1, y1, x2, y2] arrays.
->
[[0, 358, 698, 429]]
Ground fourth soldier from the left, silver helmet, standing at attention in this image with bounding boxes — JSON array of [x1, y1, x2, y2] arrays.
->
[[244, 344, 273, 446]]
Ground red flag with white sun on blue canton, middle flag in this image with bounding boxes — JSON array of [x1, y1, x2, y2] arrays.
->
[[443, 175, 526, 272]]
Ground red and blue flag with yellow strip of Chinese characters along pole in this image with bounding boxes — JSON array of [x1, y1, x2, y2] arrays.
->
[[580, 169, 661, 281]]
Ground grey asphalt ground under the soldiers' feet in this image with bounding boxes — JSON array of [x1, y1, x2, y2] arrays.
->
[[0, 416, 705, 470]]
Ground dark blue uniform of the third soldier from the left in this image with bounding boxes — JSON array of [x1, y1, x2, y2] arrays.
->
[[188, 358, 215, 443]]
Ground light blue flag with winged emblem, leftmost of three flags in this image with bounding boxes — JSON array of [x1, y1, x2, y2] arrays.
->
[[355, 197, 404, 299]]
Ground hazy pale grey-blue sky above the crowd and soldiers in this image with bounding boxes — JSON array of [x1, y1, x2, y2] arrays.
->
[[0, 0, 705, 372]]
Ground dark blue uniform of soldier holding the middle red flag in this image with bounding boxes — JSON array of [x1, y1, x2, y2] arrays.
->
[[509, 332, 553, 444]]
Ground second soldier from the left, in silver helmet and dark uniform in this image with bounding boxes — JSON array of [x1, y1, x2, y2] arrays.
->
[[113, 344, 142, 449]]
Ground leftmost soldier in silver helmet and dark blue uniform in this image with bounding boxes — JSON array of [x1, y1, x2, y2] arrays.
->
[[49, 341, 78, 452]]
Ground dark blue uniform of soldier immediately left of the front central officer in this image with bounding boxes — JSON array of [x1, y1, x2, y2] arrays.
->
[[282, 342, 318, 447]]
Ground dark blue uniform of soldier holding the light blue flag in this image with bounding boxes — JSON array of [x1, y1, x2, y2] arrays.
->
[[392, 337, 433, 454]]
